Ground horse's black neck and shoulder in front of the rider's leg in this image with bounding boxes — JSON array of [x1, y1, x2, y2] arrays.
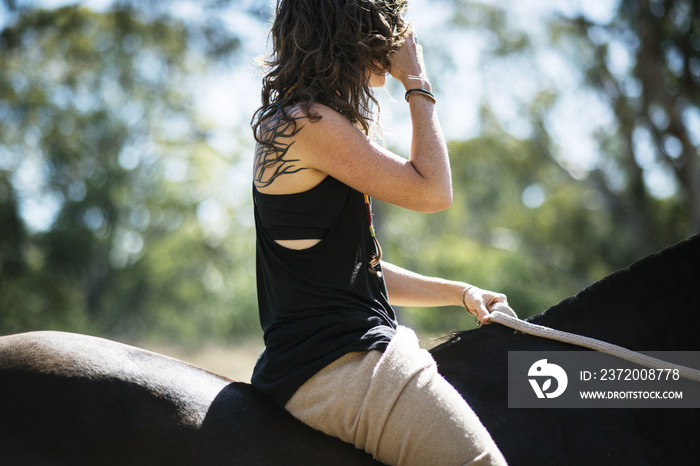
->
[[433, 236, 700, 465]]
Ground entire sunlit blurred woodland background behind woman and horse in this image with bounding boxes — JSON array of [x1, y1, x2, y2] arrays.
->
[[0, 0, 700, 377]]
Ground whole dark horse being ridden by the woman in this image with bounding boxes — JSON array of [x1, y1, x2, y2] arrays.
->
[[0, 237, 700, 466]]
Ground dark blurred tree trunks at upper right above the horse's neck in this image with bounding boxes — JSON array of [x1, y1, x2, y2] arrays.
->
[[553, 0, 700, 250]]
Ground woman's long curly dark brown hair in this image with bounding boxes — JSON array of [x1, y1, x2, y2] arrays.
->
[[252, 0, 409, 146]]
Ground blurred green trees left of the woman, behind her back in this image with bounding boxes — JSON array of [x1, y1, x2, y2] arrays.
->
[[0, 2, 254, 336]]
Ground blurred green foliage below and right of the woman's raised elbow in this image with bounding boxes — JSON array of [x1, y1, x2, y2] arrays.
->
[[379, 127, 652, 333]]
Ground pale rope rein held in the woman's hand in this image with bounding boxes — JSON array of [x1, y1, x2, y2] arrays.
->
[[489, 303, 700, 382]]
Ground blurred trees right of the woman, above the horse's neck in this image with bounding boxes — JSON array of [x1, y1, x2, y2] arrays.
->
[[380, 0, 700, 332]]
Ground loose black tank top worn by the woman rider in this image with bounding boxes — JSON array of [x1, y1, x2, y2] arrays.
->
[[251, 176, 396, 406]]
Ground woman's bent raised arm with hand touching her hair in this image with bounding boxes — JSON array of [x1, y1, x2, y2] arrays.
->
[[276, 35, 452, 212]]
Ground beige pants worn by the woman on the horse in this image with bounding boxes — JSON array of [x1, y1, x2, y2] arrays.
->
[[285, 327, 506, 466]]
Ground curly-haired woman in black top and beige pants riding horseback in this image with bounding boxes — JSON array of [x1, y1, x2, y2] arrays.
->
[[252, 0, 506, 465]]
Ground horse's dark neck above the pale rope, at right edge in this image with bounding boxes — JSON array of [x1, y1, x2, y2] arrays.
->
[[533, 236, 700, 351]]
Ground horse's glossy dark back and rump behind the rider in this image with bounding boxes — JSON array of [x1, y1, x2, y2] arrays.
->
[[0, 332, 376, 466]]
